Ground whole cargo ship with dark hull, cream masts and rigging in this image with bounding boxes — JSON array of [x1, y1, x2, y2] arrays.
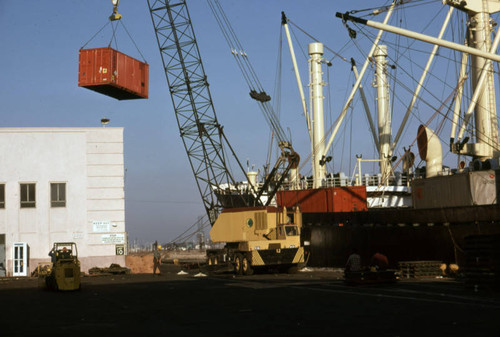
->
[[254, 0, 500, 267]]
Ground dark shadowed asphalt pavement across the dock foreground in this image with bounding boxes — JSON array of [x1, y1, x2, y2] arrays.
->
[[0, 265, 500, 337]]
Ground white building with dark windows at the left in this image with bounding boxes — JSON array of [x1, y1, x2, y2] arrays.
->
[[0, 127, 127, 276]]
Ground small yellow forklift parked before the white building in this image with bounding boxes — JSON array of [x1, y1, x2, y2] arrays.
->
[[38, 242, 81, 291]]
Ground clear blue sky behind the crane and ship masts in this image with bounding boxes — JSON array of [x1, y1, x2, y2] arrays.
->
[[0, 0, 488, 242]]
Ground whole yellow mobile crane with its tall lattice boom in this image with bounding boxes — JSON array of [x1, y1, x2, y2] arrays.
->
[[148, 0, 304, 274]]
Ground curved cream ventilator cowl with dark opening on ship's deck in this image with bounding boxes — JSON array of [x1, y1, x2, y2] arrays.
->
[[417, 125, 443, 178]]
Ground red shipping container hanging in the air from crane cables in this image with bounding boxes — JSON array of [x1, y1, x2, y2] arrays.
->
[[78, 47, 149, 100]]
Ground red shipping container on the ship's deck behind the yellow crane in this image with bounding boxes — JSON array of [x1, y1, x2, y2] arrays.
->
[[277, 186, 368, 213]]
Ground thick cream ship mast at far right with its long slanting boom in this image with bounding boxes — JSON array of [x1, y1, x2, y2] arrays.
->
[[336, 0, 500, 169]]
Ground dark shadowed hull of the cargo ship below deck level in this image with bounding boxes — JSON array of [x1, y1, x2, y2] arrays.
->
[[303, 205, 500, 267]]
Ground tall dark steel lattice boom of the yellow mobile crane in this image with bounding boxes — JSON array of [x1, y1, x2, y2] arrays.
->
[[148, 0, 260, 225]]
